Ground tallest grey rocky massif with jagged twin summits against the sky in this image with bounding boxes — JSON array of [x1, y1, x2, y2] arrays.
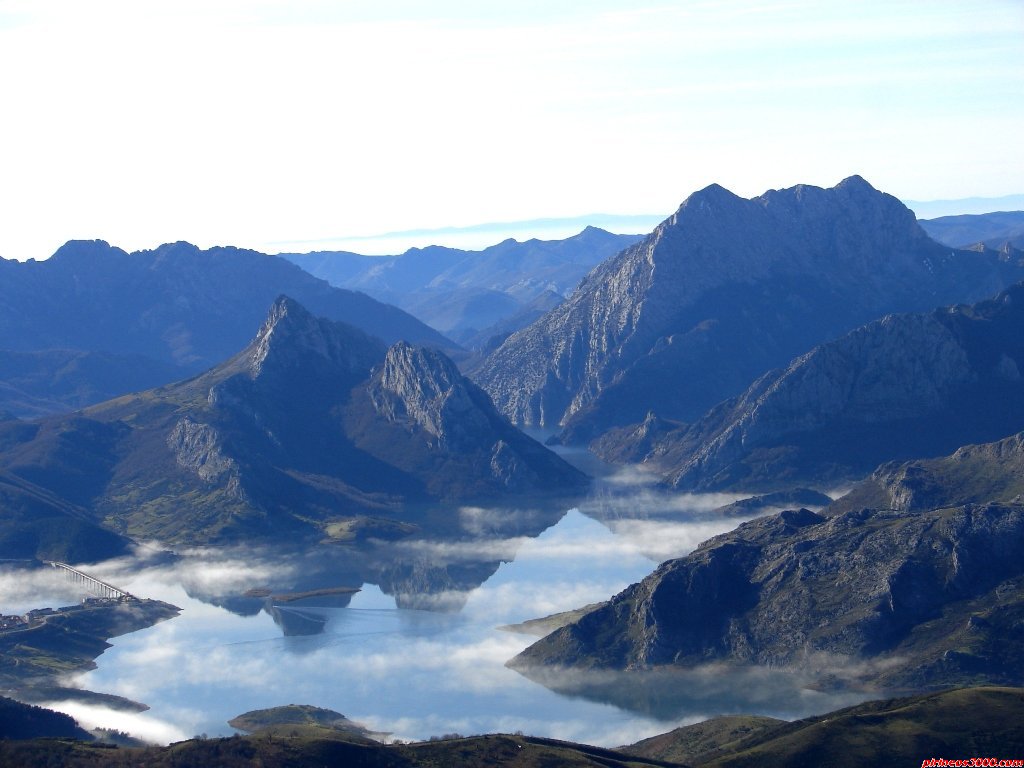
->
[[474, 176, 1024, 441]]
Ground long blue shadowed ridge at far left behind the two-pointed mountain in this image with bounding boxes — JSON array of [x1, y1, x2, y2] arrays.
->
[[0, 241, 458, 416]]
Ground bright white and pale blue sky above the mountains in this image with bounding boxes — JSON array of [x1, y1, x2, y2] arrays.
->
[[0, 0, 1024, 260]]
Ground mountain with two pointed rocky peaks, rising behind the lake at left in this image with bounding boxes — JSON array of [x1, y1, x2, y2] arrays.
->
[[0, 297, 586, 556]]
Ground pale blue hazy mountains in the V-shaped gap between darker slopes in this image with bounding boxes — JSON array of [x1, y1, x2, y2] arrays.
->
[[281, 226, 642, 347]]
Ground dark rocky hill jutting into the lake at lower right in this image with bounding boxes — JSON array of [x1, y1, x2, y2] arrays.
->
[[513, 504, 1024, 687]]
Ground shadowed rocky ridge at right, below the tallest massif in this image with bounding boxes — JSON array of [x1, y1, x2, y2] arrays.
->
[[594, 285, 1024, 489]]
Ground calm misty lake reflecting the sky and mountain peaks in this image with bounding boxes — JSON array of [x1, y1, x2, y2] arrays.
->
[[0, 476, 846, 745]]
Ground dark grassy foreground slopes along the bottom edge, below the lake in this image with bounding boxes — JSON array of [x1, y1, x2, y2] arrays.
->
[[8, 688, 1024, 768]]
